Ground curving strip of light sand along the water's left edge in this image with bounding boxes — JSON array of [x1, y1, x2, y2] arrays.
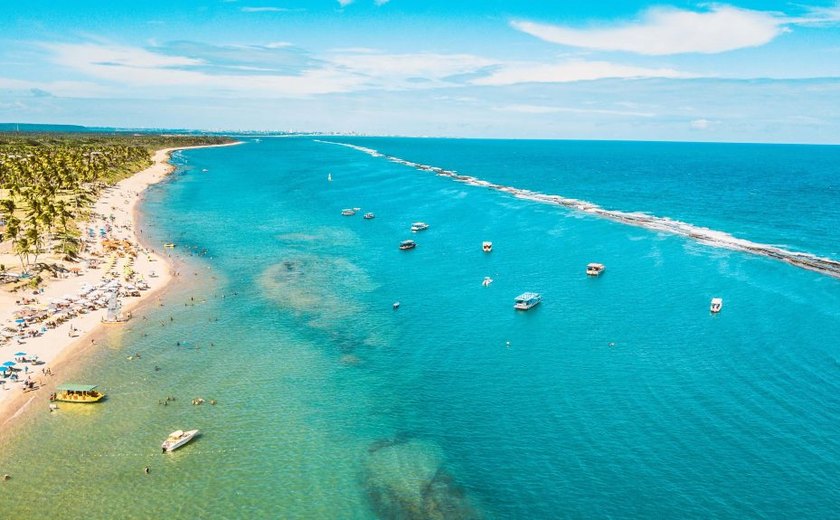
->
[[0, 141, 242, 430]]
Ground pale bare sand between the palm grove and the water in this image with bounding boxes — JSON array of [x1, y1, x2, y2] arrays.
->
[[0, 143, 238, 429]]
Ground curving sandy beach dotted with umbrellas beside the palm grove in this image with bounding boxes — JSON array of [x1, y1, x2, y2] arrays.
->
[[0, 143, 239, 430]]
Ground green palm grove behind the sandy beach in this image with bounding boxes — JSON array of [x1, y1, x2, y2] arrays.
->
[[0, 133, 231, 278]]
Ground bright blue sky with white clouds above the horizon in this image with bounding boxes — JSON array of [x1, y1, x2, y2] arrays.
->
[[0, 0, 840, 144]]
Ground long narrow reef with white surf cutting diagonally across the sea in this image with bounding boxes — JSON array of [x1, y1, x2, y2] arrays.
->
[[315, 139, 840, 278]]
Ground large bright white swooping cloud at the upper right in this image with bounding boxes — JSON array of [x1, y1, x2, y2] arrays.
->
[[510, 5, 787, 55]]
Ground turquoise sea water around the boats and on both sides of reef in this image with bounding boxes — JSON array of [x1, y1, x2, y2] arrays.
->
[[0, 138, 840, 518]]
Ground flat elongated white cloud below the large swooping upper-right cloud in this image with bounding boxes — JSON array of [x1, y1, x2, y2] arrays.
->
[[472, 60, 695, 85]]
